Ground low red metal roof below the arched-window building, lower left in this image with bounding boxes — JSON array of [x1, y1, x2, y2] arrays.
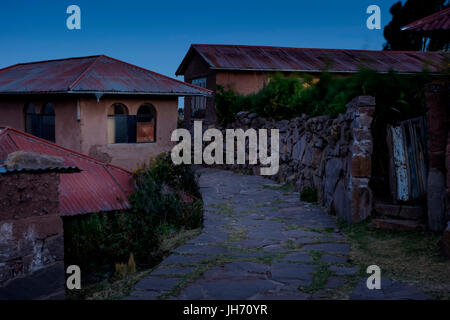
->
[[0, 127, 135, 216]]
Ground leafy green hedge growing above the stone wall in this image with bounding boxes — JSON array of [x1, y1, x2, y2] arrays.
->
[[215, 70, 429, 125]]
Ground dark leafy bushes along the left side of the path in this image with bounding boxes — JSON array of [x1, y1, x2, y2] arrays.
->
[[64, 155, 203, 274]]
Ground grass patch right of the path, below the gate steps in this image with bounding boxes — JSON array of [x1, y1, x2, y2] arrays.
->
[[339, 222, 450, 299]]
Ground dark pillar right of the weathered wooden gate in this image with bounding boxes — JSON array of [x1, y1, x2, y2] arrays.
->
[[425, 82, 449, 232]]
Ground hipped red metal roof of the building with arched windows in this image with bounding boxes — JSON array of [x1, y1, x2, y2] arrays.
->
[[0, 55, 211, 96]]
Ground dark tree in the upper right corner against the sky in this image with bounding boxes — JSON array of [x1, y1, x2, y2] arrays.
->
[[383, 0, 450, 51]]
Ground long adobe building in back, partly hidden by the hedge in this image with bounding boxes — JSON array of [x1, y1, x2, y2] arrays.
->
[[175, 44, 444, 127]]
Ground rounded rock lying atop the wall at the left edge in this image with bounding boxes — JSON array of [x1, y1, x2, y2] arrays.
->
[[5, 151, 64, 169]]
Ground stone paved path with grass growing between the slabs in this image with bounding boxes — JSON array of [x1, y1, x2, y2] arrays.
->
[[125, 168, 432, 300]]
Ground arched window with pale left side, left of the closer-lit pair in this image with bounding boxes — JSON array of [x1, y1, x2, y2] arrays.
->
[[108, 103, 129, 143]]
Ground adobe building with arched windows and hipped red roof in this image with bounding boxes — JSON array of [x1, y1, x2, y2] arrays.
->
[[0, 55, 210, 170]]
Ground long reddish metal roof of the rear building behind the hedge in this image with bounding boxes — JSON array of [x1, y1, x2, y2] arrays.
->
[[176, 44, 444, 75]]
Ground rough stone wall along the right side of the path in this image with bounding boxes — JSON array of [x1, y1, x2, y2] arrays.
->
[[210, 96, 375, 223]]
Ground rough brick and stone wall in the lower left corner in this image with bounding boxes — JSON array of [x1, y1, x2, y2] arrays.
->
[[0, 171, 65, 300]]
